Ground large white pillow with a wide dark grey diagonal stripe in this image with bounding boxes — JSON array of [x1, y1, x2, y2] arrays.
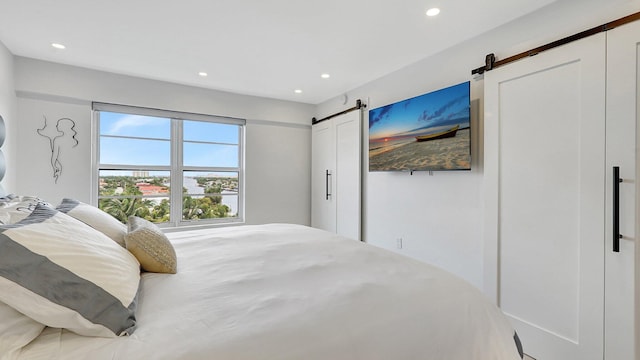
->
[[0, 204, 140, 337]]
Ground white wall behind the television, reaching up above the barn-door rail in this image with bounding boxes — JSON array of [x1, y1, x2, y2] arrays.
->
[[317, 0, 640, 288]]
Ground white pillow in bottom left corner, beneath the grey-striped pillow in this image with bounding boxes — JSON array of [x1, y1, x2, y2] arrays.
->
[[0, 303, 44, 359]]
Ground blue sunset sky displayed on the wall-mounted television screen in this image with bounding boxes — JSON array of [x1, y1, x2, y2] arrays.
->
[[369, 82, 470, 141]]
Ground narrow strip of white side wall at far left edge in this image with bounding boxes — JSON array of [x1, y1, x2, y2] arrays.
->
[[0, 42, 18, 194]]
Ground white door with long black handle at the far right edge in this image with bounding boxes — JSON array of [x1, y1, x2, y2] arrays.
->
[[605, 22, 640, 360]]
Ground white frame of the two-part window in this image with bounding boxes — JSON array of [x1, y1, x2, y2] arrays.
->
[[91, 102, 246, 230]]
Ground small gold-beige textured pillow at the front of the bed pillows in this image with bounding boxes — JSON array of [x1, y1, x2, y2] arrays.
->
[[124, 216, 177, 274]]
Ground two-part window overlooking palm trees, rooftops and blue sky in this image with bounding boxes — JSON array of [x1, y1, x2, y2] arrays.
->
[[93, 103, 245, 227]]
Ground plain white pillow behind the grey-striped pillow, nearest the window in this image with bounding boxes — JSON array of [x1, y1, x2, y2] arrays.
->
[[56, 198, 127, 247]]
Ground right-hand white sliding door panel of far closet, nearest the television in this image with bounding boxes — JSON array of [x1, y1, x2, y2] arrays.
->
[[334, 110, 361, 240]]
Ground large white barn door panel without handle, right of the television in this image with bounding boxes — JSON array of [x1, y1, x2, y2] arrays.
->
[[484, 34, 609, 360]]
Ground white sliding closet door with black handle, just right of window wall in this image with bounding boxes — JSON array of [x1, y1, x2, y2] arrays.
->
[[311, 121, 336, 232]]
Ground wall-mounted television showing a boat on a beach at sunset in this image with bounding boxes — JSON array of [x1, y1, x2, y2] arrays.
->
[[369, 81, 471, 172]]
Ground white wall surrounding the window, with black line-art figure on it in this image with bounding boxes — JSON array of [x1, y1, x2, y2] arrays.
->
[[12, 57, 315, 225]]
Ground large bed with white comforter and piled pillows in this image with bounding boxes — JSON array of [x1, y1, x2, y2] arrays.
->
[[0, 198, 522, 360]]
